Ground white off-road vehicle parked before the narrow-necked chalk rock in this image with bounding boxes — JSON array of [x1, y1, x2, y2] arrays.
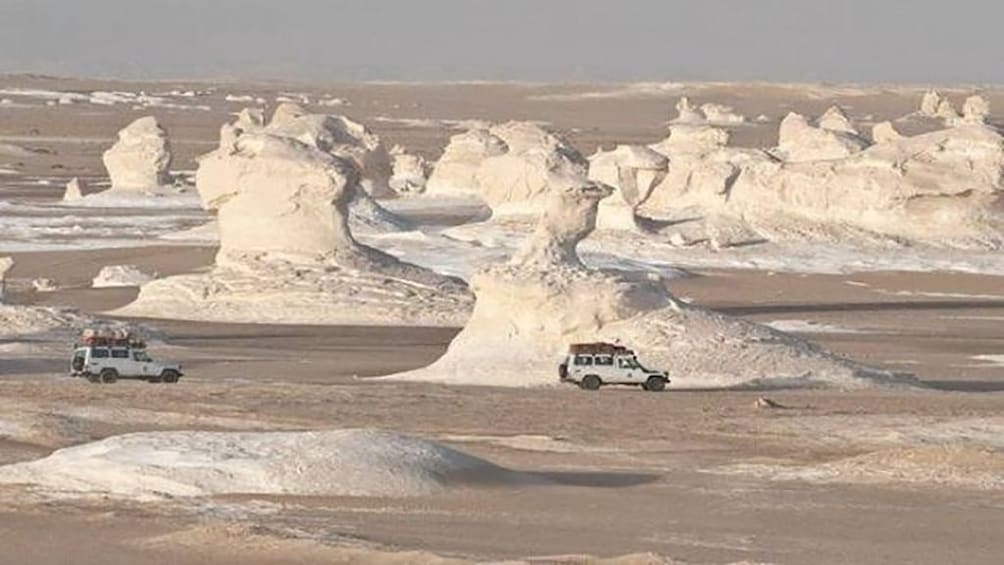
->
[[558, 343, 670, 392]]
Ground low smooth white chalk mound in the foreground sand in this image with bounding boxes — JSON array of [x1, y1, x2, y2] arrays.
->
[[0, 430, 528, 501]]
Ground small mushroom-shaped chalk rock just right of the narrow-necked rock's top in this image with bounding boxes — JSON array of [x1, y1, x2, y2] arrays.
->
[[589, 146, 669, 231]]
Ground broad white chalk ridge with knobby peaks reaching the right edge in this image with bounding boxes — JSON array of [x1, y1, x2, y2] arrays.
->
[[641, 103, 1004, 249]]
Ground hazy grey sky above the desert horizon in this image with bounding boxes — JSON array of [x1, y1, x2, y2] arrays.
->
[[0, 0, 1004, 83]]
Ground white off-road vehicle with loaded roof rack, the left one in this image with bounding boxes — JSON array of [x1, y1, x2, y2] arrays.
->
[[69, 330, 183, 383]]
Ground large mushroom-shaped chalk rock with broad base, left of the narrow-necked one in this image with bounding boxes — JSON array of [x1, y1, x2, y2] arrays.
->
[[119, 130, 470, 325]]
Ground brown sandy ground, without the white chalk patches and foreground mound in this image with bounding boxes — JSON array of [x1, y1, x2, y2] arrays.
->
[[0, 77, 1004, 564]]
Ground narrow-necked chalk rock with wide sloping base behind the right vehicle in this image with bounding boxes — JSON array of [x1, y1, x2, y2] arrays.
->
[[391, 178, 889, 388]]
